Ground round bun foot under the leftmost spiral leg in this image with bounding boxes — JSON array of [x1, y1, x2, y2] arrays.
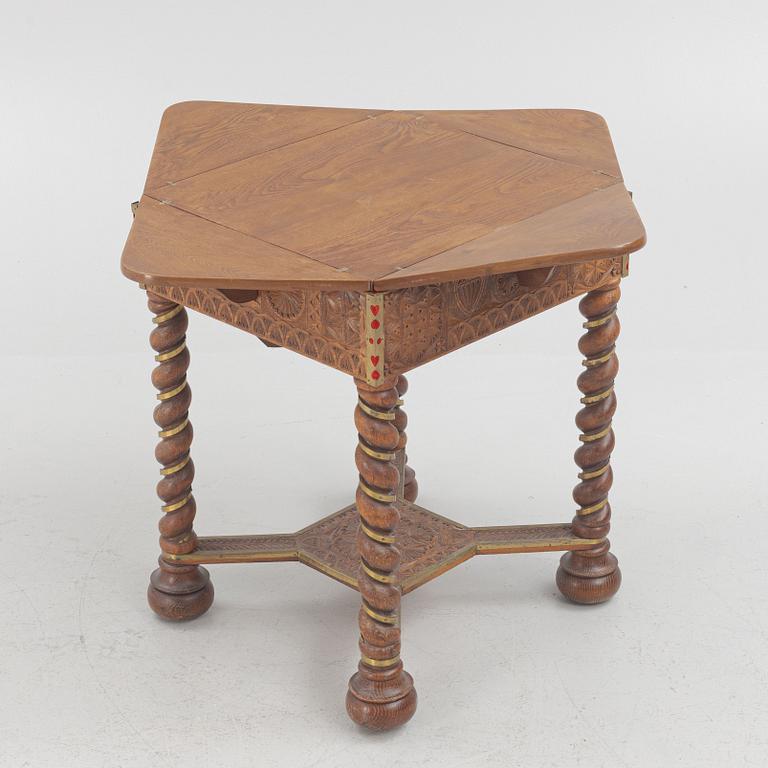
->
[[147, 562, 213, 621]]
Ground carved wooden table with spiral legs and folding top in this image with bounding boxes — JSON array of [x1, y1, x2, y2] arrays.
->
[[122, 102, 645, 729]]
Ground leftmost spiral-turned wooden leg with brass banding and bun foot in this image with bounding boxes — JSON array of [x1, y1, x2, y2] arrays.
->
[[147, 292, 213, 621]]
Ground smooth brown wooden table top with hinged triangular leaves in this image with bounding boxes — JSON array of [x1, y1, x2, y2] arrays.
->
[[122, 102, 645, 290]]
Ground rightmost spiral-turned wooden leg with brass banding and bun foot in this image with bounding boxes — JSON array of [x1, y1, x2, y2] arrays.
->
[[557, 279, 621, 603]]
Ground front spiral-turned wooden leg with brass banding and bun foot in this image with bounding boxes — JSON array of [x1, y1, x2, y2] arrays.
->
[[347, 379, 416, 730]]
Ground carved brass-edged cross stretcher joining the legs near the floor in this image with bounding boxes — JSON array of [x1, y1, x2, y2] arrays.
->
[[168, 500, 600, 594]]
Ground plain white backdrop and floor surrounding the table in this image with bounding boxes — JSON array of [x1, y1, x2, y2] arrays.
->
[[0, 0, 768, 768]]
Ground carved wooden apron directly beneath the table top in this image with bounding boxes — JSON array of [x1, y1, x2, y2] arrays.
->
[[147, 256, 622, 384]]
